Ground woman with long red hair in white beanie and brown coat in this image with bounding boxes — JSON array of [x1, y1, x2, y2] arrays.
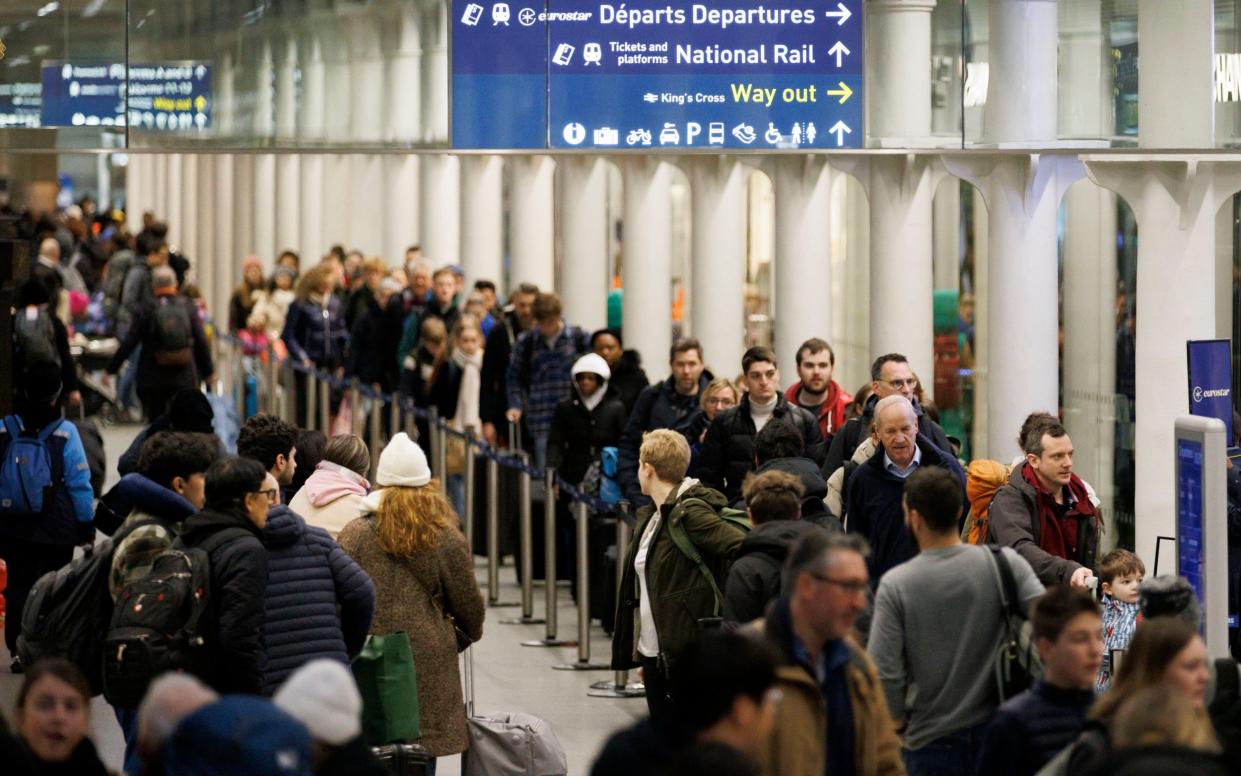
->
[[339, 432, 485, 772]]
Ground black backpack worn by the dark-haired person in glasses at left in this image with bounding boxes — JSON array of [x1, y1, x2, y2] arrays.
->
[[103, 528, 249, 709]]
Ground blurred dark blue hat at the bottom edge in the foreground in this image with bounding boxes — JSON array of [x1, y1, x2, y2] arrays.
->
[[164, 695, 313, 776]]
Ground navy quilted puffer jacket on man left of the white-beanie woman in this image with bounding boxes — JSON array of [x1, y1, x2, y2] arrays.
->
[[263, 504, 375, 695]]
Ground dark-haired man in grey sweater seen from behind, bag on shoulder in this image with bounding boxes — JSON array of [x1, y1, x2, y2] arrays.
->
[[867, 467, 1042, 776]]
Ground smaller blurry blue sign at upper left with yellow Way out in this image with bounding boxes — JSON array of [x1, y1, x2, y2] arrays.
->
[[41, 62, 211, 132]]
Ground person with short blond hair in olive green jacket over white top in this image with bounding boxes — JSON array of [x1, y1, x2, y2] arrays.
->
[[612, 428, 745, 724]]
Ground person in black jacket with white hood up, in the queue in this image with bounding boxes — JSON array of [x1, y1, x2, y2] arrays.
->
[[547, 353, 625, 483]]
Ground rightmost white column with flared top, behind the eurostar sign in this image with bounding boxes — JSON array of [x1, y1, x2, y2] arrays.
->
[[1083, 155, 1241, 568]]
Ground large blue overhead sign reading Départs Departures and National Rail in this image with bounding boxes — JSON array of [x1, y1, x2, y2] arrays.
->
[[453, 0, 864, 151]]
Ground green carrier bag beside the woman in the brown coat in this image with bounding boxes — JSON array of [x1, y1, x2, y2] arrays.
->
[[354, 633, 422, 746]]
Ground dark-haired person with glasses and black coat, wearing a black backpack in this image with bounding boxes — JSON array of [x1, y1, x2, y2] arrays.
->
[[181, 457, 280, 695]]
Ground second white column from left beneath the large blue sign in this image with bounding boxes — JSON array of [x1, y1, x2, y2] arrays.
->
[[509, 156, 556, 291]]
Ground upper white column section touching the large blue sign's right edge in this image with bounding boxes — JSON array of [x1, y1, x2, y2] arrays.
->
[[868, 0, 936, 148]]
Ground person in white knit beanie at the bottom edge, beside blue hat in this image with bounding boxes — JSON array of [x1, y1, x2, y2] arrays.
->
[[272, 661, 386, 776]]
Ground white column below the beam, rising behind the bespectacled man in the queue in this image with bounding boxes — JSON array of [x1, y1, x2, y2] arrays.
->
[[841, 155, 942, 394]]
